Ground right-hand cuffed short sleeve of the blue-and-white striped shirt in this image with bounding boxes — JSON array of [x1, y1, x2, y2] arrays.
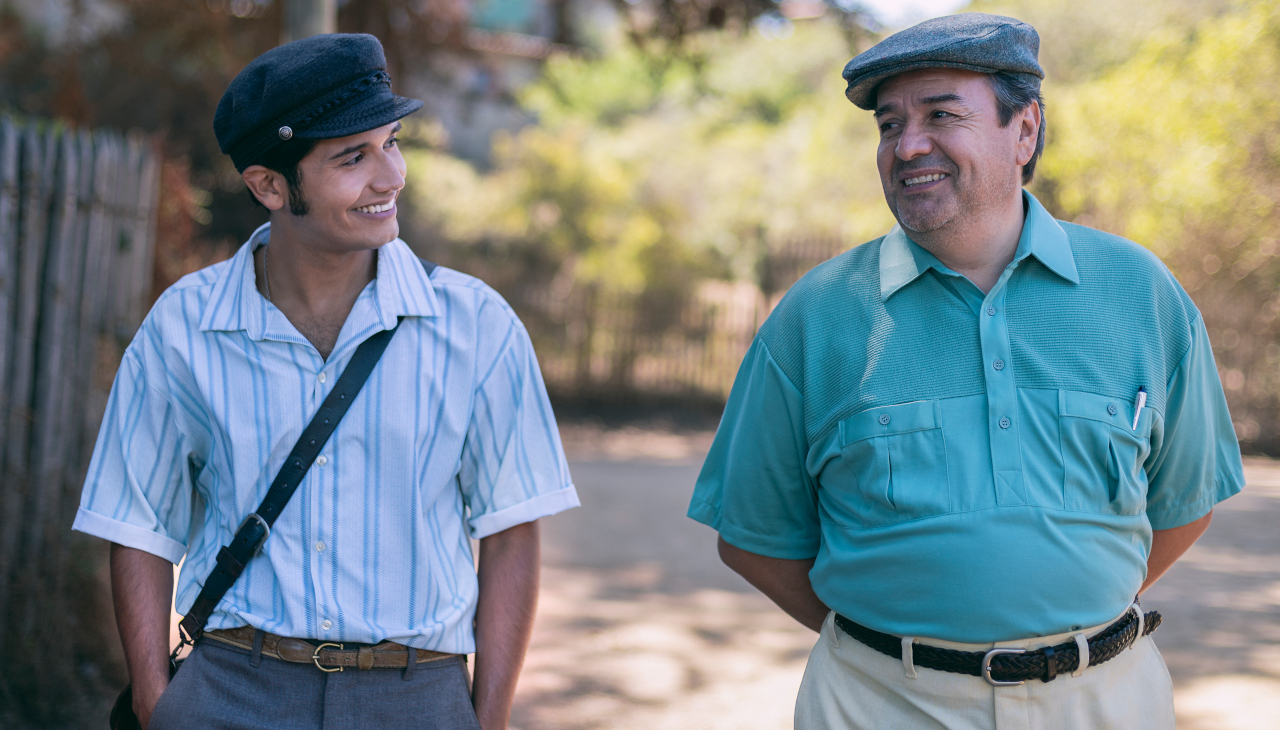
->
[[458, 307, 579, 539]]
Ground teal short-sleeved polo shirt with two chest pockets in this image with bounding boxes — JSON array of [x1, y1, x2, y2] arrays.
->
[[689, 195, 1244, 643]]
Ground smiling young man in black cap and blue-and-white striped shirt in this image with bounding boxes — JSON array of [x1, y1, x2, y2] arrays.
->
[[74, 35, 577, 730]]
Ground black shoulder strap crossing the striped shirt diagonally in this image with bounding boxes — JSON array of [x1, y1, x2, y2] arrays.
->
[[180, 317, 399, 642]]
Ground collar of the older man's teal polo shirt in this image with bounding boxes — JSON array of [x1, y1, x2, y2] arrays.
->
[[879, 191, 1080, 301]]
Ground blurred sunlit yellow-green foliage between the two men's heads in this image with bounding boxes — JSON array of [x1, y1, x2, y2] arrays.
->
[[411, 22, 892, 292]]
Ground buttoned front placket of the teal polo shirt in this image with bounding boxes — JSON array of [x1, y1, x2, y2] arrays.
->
[[978, 270, 1027, 505]]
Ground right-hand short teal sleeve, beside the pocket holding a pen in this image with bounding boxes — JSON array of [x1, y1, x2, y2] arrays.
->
[[1147, 316, 1244, 530]]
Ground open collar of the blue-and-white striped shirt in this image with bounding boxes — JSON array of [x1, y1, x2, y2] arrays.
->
[[200, 223, 438, 339]]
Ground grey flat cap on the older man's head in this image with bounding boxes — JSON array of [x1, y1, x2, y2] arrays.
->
[[844, 13, 1044, 109]]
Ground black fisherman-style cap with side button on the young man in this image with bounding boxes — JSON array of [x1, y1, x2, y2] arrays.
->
[[214, 33, 422, 172]]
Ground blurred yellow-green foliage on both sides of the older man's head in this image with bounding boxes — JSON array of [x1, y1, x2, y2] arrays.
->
[[411, 0, 1280, 438]]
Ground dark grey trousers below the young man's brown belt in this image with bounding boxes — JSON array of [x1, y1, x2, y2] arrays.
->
[[150, 632, 480, 730]]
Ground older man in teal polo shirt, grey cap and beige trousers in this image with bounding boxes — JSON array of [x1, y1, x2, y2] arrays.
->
[[690, 13, 1243, 730]]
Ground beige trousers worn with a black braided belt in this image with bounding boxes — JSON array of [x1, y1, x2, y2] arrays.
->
[[795, 613, 1174, 730]]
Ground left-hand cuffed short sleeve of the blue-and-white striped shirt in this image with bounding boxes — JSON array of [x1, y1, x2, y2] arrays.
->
[[72, 347, 193, 565]]
